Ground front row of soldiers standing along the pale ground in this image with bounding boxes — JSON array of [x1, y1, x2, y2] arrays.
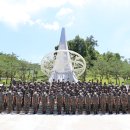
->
[[0, 91, 130, 114]]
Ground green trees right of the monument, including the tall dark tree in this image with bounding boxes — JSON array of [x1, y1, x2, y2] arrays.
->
[[55, 35, 130, 84]]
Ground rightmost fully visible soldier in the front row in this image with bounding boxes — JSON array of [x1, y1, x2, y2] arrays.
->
[[121, 92, 128, 113]]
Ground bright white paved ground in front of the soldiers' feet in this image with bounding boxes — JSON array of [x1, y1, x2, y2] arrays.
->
[[0, 113, 130, 130]]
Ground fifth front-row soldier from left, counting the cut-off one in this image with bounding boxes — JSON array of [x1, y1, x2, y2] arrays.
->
[[32, 91, 39, 114]]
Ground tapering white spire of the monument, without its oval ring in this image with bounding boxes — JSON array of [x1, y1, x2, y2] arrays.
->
[[49, 28, 78, 82]]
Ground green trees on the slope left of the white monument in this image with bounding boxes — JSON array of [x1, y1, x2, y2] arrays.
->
[[0, 52, 47, 84]]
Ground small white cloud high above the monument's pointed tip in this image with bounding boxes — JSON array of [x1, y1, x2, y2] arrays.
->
[[56, 8, 73, 17]]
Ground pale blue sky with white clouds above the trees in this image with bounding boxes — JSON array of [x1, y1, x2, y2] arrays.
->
[[0, 0, 130, 63]]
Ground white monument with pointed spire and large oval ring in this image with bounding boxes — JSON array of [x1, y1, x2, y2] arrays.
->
[[41, 28, 86, 82]]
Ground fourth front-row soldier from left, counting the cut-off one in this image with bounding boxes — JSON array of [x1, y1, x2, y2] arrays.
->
[[24, 91, 31, 114]]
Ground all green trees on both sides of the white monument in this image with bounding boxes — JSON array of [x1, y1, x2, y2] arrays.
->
[[0, 35, 130, 84]]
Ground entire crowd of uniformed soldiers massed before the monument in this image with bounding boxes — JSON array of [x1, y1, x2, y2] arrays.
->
[[0, 81, 130, 114]]
